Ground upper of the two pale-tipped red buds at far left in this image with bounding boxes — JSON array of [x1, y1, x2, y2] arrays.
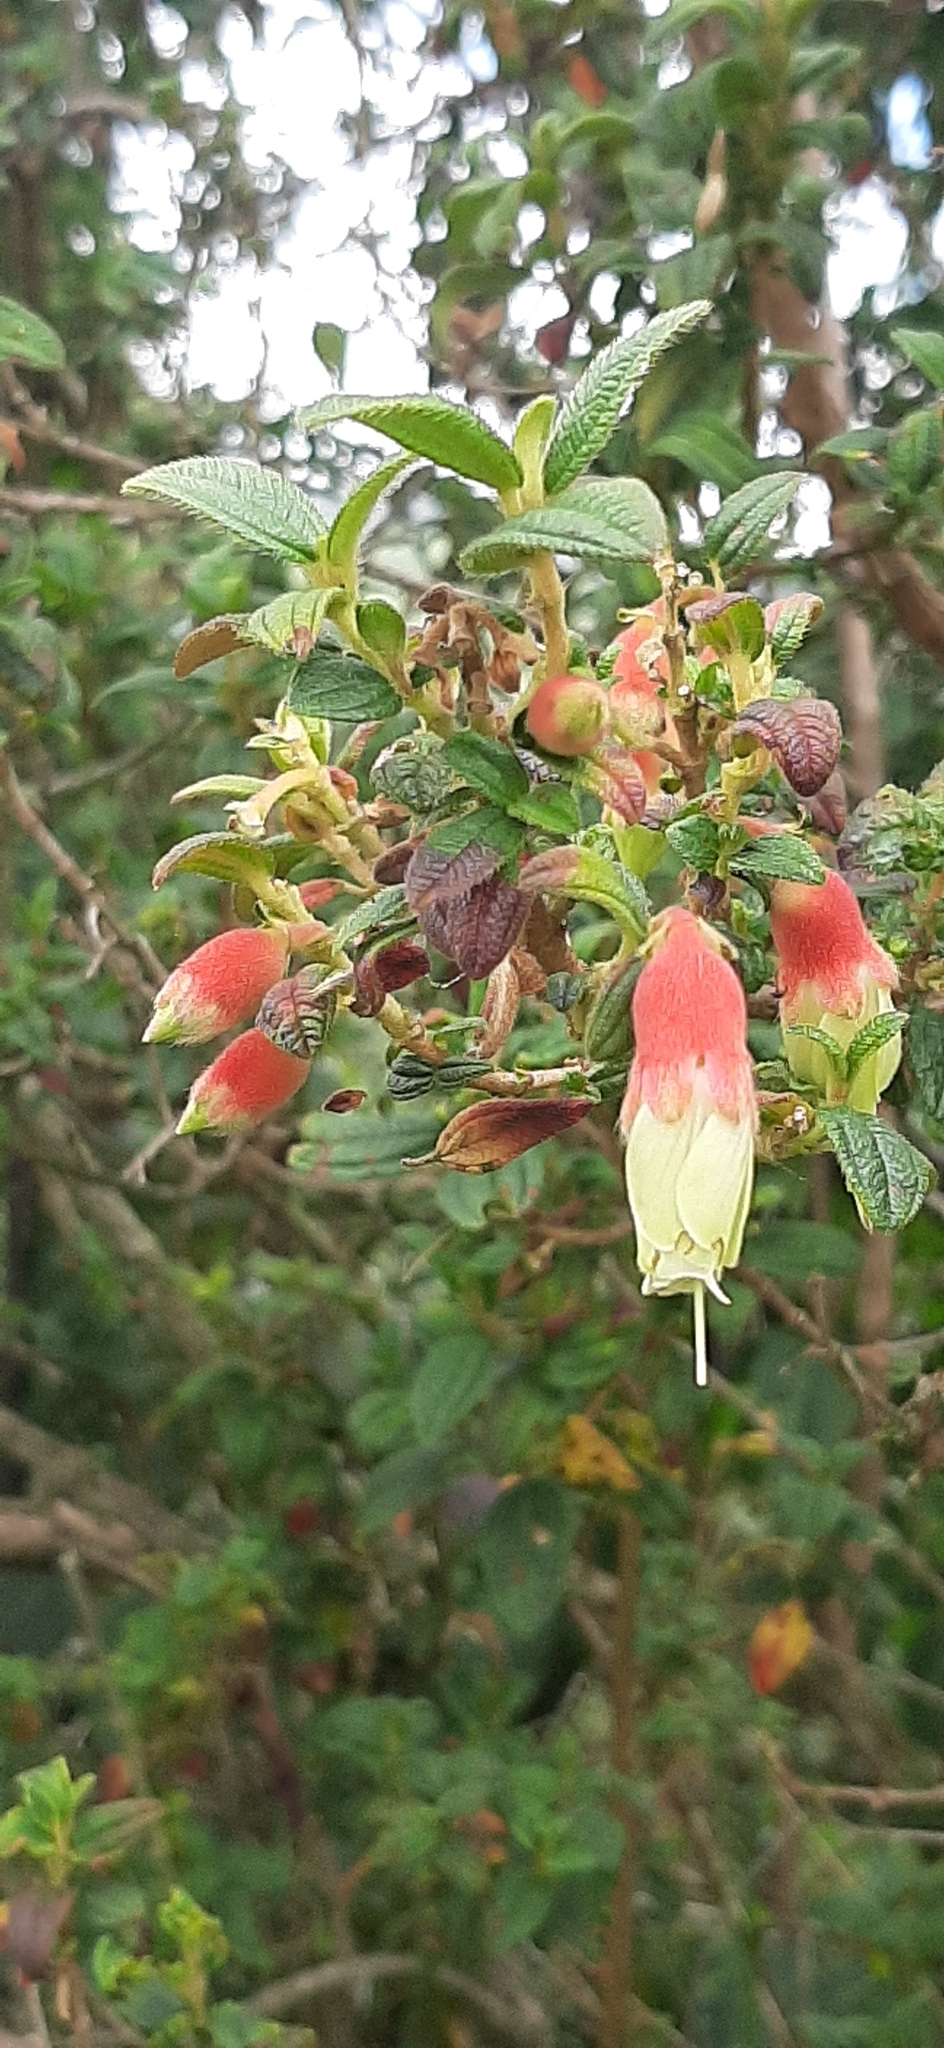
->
[[143, 926, 289, 1044]]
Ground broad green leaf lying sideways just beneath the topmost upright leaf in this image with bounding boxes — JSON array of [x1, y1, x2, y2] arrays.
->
[[459, 477, 668, 575]]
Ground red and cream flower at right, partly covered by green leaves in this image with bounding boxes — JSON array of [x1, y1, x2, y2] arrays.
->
[[770, 868, 901, 1114]]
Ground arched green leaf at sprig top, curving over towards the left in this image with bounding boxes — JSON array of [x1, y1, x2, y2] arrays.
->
[[301, 393, 522, 492]]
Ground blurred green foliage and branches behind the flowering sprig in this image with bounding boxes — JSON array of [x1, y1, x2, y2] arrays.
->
[[0, 0, 944, 2048]]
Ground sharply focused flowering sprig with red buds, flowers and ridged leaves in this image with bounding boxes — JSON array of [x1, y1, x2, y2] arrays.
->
[[127, 301, 938, 1384]]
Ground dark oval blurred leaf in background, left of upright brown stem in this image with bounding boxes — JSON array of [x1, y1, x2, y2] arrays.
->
[[477, 1479, 582, 1636]]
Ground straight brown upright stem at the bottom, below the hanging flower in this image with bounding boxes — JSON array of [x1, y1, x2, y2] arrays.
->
[[598, 1507, 643, 2048]]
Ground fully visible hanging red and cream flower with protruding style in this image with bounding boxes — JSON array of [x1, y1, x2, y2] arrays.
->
[[620, 905, 758, 1386]]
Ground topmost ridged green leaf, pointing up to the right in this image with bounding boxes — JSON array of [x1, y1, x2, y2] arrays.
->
[[545, 299, 711, 496]]
